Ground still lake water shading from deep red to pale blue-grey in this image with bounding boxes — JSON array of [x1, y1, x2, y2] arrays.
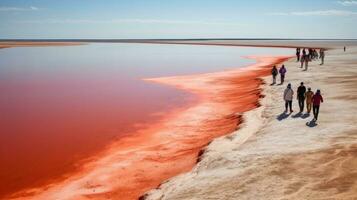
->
[[0, 44, 287, 198]]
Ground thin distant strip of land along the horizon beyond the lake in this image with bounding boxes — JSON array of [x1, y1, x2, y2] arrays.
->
[[0, 39, 357, 49]]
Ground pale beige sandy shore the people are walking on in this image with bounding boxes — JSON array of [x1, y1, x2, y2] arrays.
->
[[145, 45, 357, 200]]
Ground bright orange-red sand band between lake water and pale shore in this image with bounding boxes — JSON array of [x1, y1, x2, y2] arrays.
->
[[8, 56, 290, 200]]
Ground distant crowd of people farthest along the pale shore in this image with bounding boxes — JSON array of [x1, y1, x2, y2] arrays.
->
[[296, 48, 325, 70]]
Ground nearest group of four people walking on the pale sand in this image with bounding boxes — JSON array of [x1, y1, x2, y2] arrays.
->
[[284, 82, 323, 121]]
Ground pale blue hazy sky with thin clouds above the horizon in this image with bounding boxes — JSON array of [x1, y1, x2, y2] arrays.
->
[[0, 0, 357, 39]]
